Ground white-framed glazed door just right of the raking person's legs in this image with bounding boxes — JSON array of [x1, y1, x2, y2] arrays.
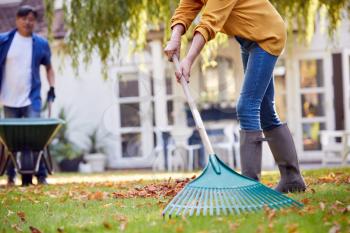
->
[[294, 52, 334, 161]]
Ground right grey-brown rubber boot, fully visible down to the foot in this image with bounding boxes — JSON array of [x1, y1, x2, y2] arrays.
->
[[264, 124, 306, 193]]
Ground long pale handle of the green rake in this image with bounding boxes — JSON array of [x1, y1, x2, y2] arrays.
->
[[173, 55, 214, 155]]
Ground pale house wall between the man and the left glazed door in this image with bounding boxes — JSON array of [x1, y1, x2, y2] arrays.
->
[[42, 45, 115, 165]]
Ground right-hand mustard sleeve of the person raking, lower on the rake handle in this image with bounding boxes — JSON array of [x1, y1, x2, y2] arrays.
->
[[194, 0, 237, 41]]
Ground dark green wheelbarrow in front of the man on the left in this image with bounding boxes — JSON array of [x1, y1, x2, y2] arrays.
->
[[0, 118, 64, 184]]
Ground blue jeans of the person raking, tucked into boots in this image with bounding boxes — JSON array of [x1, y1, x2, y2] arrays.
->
[[236, 37, 282, 131]]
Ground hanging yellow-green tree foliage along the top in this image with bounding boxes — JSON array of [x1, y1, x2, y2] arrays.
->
[[45, 0, 350, 71]]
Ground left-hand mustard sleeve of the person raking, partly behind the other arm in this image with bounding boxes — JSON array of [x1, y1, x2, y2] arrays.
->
[[171, 0, 203, 31]]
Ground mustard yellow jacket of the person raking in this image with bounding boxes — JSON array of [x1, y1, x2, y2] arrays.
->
[[171, 0, 287, 56]]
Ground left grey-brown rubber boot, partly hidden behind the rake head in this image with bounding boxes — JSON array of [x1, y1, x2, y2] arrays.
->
[[240, 130, 262, 181]]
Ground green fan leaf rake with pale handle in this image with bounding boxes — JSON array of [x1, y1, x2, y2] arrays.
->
[[162, 55, 303, 218]]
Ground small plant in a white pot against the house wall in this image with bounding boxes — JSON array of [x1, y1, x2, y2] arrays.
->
[[84, 129, 106, 172]]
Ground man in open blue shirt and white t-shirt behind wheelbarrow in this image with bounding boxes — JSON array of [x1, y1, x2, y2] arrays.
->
[[0, 5, 55, 185]]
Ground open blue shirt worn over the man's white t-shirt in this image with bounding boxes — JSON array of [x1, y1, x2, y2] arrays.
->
[[0, 29, 51, 112]]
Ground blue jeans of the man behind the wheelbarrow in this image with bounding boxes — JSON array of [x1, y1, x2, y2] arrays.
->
[[4, 106, 47, 179]]
